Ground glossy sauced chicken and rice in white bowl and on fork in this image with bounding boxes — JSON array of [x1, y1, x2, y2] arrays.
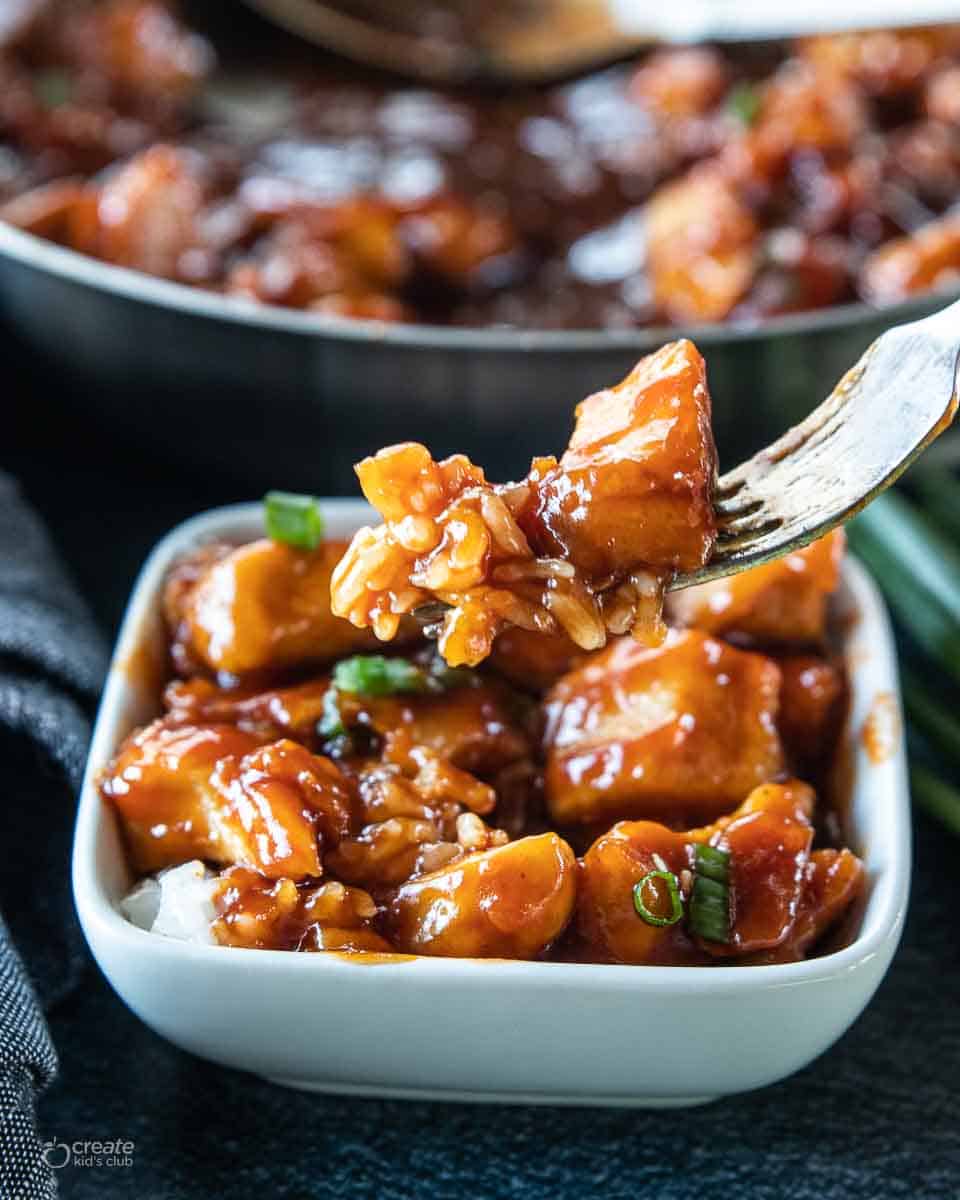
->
[[100, 341, 868, 965]]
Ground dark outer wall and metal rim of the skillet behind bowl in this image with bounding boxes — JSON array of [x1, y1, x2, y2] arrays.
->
[[0, 223, 947, 493]]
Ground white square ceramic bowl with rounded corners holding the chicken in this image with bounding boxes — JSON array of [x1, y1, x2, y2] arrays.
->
[[73, 500, 911, 1106]]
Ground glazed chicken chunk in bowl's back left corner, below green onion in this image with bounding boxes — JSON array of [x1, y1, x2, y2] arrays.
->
[[164, 539, 373, 678]]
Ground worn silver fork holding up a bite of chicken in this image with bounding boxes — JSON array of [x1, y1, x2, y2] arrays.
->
[[668, 301, 960, 589]]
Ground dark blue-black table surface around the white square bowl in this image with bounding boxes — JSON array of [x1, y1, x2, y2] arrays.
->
[[7, 331, 960, 1200]]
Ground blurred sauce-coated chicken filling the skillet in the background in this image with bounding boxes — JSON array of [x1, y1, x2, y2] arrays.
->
[[0, 0, 960, 329]]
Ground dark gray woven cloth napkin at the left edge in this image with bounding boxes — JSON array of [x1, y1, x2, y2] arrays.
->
[[0, 474, 107, 1200]]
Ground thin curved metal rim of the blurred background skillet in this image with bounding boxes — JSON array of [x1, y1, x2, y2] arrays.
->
[[0, 221, 960, 355]]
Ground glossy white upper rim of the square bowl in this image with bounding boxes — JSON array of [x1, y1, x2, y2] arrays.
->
[[72, 498, 912, 995]]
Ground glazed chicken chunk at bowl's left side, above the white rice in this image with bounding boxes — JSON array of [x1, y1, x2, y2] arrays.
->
[[100, 720, 355, 880]]
